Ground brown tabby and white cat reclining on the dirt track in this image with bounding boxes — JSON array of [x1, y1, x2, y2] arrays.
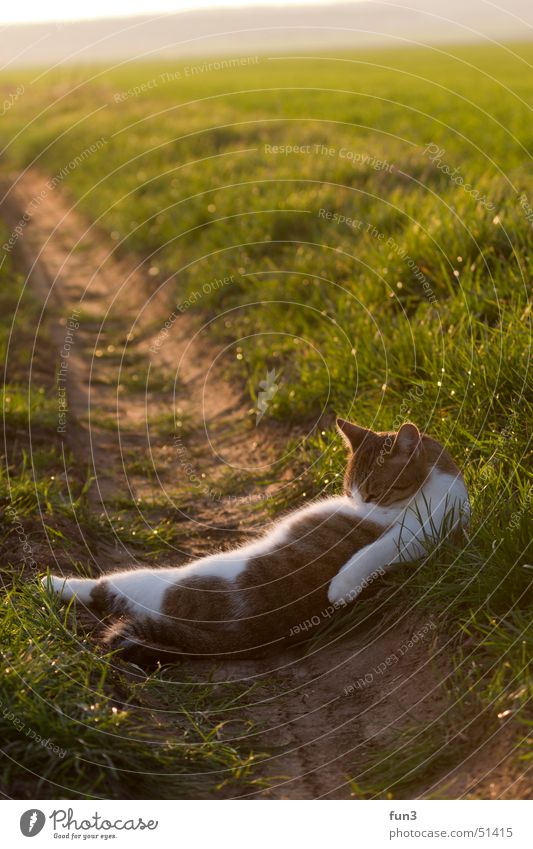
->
[[43, 419, 469, 663]]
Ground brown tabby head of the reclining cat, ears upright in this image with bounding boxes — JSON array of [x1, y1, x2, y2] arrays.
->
[[337, 419, 429, 505]]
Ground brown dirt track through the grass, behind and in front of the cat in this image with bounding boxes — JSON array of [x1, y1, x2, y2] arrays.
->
[[2, 171, 448, 799]]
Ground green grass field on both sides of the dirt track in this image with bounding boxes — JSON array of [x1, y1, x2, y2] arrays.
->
[[0, 45, 533, 798]]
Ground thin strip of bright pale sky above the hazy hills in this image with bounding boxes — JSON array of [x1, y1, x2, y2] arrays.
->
[[0, 0, 348, 24]]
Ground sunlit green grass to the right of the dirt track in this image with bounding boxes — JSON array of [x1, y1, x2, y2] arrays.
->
[[0, 39, 533, 797]]
